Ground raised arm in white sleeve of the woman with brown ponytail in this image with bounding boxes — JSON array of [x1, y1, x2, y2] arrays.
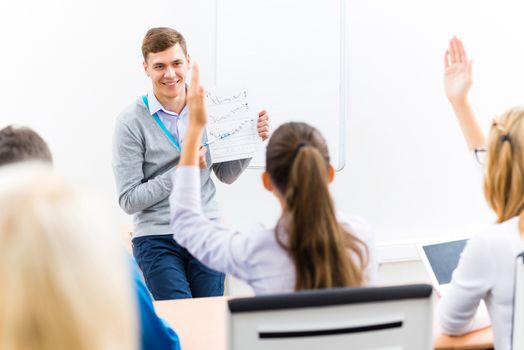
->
[[169, 65, 253, 280]]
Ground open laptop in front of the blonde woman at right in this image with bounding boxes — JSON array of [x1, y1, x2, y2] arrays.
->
[[417, 239, 491, 331]]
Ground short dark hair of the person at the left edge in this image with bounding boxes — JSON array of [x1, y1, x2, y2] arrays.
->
[[0, 125, 53, 165]]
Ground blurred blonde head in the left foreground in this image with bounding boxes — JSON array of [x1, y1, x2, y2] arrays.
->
[[0, 163, 139, 350]]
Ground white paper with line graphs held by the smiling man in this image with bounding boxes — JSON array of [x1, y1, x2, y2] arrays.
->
[[206, 88, 259, 163]]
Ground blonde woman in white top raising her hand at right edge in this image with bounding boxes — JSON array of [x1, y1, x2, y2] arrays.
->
[[439, 37, 524, 350]]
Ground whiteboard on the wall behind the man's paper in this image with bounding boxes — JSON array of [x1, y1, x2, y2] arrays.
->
[[215, 0, 346, 169]]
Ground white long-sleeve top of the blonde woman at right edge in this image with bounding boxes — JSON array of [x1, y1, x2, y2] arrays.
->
[[439, 217, 524, 350]]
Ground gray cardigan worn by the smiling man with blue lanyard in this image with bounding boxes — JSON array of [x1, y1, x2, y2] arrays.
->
[[112, 98, 251, 237]]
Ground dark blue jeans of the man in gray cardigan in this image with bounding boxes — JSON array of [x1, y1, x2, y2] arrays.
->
[[133, 235, 225, 300]]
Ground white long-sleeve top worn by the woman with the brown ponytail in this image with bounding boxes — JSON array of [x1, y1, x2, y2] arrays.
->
[[169, 166, 377, 295]]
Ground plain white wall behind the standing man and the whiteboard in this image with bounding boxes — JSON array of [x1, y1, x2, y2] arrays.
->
[[0, 0, 524, 260]]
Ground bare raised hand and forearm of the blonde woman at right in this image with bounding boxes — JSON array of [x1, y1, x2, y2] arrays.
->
[[444, 37, 485, 151]]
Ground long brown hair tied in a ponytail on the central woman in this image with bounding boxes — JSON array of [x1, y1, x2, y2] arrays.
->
[[266, 123, 367, 290]]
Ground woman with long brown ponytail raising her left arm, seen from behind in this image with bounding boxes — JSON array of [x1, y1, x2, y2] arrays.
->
[[170, 66, 377, 294]]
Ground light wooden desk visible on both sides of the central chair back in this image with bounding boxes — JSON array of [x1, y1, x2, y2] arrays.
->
[[154, 297, 493, 350]]
